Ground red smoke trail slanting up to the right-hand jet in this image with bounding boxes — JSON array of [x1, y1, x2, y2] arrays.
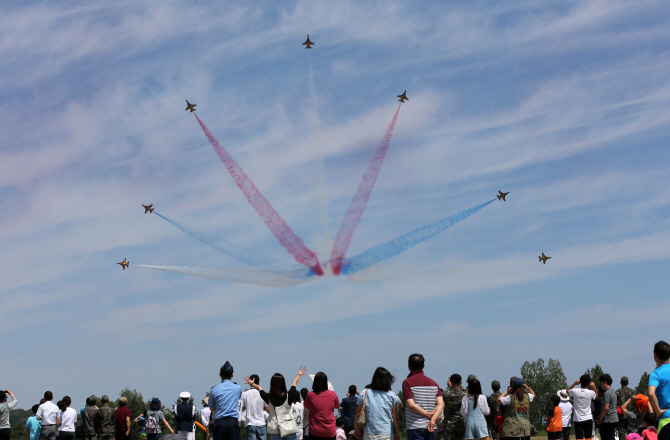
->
[[330, 104, 402, 275]]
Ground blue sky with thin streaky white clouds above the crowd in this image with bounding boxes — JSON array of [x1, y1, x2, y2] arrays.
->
[[0, 1, 670, 408]]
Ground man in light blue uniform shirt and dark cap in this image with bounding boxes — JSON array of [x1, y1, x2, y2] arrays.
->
[[209, 361, 242, 440]]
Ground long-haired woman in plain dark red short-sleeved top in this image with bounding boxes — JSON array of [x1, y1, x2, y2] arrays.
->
[[305, 371, 340, 440]]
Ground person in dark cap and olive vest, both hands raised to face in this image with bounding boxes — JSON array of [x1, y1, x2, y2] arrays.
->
[[497, 377, 535, 440]]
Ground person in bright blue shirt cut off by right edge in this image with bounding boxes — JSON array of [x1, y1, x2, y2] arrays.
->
[[648, 341, 670, 440]]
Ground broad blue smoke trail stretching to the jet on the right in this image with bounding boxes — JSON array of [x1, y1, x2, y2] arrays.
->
[[342, 199, 496, 275]]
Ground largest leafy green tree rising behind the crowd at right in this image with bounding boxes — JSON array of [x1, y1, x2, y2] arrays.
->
[[521, 358, 568, 431]]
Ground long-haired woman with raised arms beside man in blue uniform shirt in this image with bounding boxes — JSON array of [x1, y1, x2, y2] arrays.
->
[[244, 367, 307, 440]]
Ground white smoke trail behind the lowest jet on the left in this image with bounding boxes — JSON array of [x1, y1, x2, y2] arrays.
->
[[136, 264, 313, 287]]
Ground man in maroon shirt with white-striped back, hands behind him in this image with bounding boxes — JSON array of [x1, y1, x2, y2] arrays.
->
[[402, 353, 444, 440]]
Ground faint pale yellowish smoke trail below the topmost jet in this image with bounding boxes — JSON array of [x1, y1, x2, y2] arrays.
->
[[308, 52, 332, 262]]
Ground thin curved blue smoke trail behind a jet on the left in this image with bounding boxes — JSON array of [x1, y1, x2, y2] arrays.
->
[[154, 211, 312, 278]]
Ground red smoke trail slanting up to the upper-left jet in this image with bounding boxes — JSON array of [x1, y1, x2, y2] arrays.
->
[[194, 113, 323, 276]]
